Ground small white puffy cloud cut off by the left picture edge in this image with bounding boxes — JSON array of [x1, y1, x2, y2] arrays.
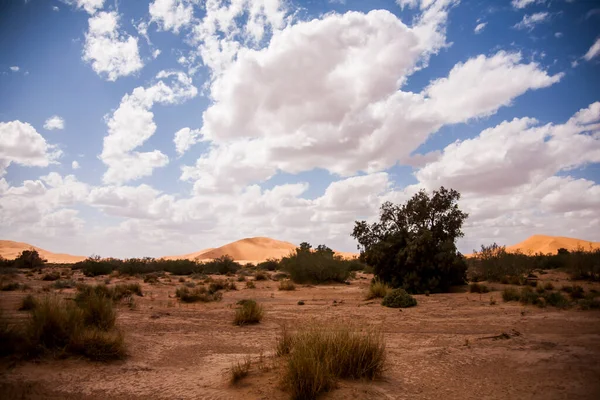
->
[[0, 121, 61, 176]]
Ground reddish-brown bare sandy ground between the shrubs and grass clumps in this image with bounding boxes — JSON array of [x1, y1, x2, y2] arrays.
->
[[0, 273, 600, 400]]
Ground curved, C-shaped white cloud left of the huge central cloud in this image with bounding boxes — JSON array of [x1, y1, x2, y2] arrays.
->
[[100, 71, 198, 183]]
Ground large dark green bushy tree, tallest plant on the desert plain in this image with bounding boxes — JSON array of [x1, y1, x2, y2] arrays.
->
[[352, 186, 468, 293]]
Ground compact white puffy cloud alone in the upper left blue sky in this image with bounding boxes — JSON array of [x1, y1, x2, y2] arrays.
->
[[83, 11, 144, 81]]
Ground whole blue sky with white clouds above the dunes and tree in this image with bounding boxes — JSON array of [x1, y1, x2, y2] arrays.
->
[[0, 0, 600, 257]]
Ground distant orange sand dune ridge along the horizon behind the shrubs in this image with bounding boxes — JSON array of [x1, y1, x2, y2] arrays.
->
[[0, 235, 600, 264]]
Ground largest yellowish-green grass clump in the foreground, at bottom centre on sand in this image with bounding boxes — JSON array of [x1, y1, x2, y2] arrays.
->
[[282, 327, 385, 399]]
